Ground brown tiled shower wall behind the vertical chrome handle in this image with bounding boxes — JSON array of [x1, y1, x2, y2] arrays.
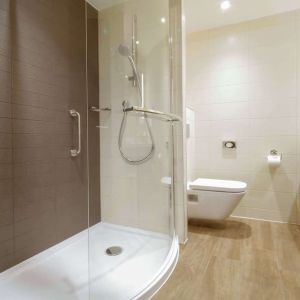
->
[[0, 0, 99, 271]]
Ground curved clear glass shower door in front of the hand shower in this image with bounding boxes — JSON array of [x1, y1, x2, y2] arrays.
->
[[87, 0, 178, 300]]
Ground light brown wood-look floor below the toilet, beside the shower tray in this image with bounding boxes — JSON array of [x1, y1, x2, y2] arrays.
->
[[154, 219, 300, 300]]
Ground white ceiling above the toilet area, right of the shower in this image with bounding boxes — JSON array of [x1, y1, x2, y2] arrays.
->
[[184, 0, 300, 32]]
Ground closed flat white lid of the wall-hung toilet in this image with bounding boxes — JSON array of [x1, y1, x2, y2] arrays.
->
[[189, 178, 247, 193]]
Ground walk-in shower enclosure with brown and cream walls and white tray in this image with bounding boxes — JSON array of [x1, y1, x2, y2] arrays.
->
[[0, 0, 180, 300]]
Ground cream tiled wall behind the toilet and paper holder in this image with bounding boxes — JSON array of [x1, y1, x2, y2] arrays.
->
[[187, 11, 300, 223]]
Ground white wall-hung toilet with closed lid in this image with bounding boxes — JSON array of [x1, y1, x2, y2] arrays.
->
[[187, 178, 247, 221]]
